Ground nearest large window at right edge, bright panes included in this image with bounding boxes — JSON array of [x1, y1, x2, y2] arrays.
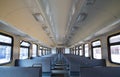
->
[[108, 34, 120, 64]]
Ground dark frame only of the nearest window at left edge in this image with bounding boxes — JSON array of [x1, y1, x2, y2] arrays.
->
[[0, 32, 14, 65]]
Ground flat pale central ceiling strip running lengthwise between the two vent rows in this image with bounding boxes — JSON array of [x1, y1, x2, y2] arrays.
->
[[39, 0, 78, 44]]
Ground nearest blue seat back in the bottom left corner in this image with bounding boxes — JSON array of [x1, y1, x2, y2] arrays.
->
[[0, 66, 42, 77]]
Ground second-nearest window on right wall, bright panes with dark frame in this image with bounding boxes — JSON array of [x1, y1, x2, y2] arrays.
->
[[92, 40, 102, 59]]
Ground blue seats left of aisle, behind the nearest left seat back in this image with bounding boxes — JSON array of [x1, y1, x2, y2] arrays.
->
[[15, 54, 57, 77]]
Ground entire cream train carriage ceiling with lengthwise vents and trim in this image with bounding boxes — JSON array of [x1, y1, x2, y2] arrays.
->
[[0, 0, 120, 47]]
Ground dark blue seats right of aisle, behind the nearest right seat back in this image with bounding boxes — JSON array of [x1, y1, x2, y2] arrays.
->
[[63, 54, 106, 76]]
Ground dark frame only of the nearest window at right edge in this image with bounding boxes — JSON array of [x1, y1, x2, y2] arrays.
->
[[107, 32, 120, 65]]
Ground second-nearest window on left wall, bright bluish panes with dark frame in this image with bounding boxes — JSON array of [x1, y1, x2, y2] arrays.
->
[[19, 41, 30, 59]]
